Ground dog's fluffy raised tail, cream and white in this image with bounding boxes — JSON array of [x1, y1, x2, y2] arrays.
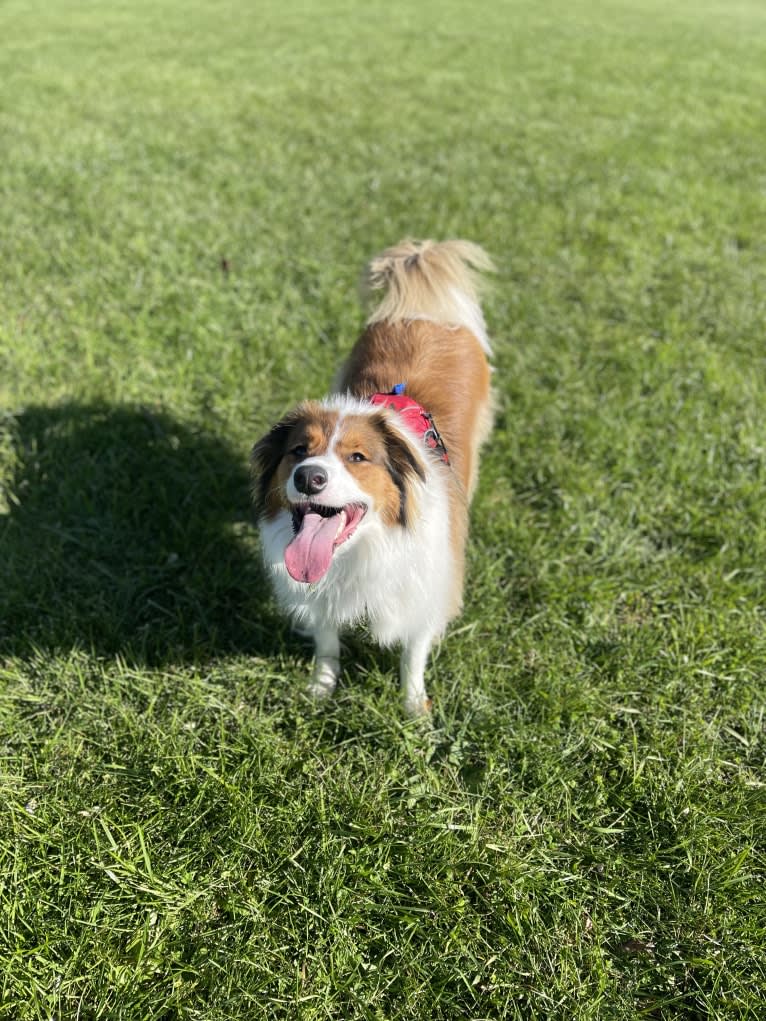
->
[[365, 240, 493, 354]]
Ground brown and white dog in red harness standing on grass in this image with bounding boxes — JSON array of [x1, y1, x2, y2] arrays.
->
[[251, 240, 492, 716]]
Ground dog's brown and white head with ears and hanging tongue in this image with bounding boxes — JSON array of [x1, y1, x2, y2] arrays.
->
[[252, 401, 425, 583]]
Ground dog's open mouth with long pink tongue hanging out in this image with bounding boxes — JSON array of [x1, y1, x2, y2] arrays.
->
[[285, 501, 367, 584]]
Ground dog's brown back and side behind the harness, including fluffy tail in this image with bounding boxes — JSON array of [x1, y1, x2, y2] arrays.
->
[[337, 235, 492, 499]]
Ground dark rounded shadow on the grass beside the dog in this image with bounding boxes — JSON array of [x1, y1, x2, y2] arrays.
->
[[0, 403, 291, 665]]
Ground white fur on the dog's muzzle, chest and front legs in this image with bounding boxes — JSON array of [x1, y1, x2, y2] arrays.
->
[[260, 396, 454, 715]]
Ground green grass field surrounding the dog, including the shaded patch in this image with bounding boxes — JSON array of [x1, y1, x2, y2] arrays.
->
[[0, 0, 766, 1021]]
